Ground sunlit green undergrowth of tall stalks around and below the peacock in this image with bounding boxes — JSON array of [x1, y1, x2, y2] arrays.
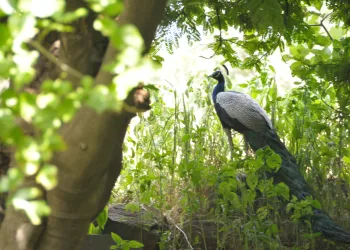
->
[[113, 67, 350, 250]]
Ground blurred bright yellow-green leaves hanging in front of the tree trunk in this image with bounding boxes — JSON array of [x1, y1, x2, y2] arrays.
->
[[0, 0, 154, 225]]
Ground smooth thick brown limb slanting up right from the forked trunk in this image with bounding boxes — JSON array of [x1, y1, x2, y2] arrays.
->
[[38, 0, 165, 250]]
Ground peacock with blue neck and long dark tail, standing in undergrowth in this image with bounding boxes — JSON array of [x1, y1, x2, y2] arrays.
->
[[209, 70, 350, 243]]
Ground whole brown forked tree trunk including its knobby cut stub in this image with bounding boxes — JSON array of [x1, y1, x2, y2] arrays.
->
[[0, 0, 166, 250]]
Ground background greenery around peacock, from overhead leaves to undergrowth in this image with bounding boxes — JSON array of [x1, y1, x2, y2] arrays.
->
[[115, 0, 350, 249]]
